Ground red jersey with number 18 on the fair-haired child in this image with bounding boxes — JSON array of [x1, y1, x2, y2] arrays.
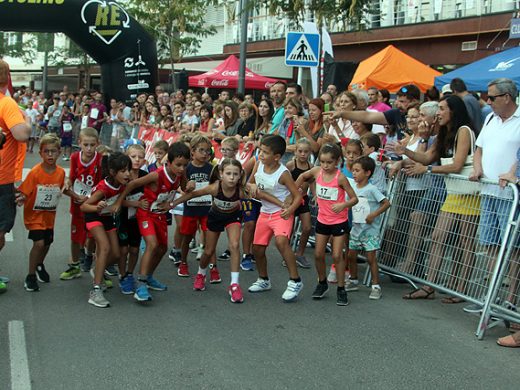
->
[[69, 151, 103, 214]]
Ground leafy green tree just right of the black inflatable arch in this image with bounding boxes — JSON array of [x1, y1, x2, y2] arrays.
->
[[126, 0, 217, 89]]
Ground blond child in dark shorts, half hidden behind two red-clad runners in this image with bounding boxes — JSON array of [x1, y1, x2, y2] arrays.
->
[[117, 144, 149, 295]]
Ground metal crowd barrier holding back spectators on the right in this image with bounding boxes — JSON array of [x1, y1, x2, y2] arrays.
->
[[378, 172, 520, 339]]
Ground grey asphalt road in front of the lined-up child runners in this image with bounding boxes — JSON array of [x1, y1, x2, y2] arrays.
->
[[0, 155, 520, 390]]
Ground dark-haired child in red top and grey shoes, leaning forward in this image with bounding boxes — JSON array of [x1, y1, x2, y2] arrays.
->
[[80, 152, 132, 307]]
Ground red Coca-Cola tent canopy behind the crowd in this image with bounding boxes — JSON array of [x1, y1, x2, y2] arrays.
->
[[189, 55, 278, 89]]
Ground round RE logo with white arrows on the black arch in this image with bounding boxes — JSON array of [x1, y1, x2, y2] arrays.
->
[[81, 0, 130, 45]]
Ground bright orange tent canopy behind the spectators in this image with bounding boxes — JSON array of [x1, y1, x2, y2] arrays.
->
[[350, 45, 441, 93]]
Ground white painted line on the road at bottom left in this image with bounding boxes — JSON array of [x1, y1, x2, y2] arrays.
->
[[9, 321, 31, 390]]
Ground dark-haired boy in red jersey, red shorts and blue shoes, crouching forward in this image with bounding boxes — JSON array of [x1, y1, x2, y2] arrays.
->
[[116, 142, 190, 302]]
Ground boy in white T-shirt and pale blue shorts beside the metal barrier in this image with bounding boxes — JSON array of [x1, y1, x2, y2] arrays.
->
[[345, 156, 390, 299]]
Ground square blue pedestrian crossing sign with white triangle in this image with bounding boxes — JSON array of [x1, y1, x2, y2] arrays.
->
[[285, 32, 320, 67]]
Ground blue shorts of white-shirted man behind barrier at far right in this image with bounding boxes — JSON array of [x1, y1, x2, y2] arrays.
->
[[479, 195, 518, 245]]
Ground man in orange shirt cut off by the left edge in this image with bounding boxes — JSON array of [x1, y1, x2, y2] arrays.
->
[[0, 60, 31, 293]]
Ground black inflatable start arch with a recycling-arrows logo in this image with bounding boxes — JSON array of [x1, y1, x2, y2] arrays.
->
[[0, 0, 157, 101]]
